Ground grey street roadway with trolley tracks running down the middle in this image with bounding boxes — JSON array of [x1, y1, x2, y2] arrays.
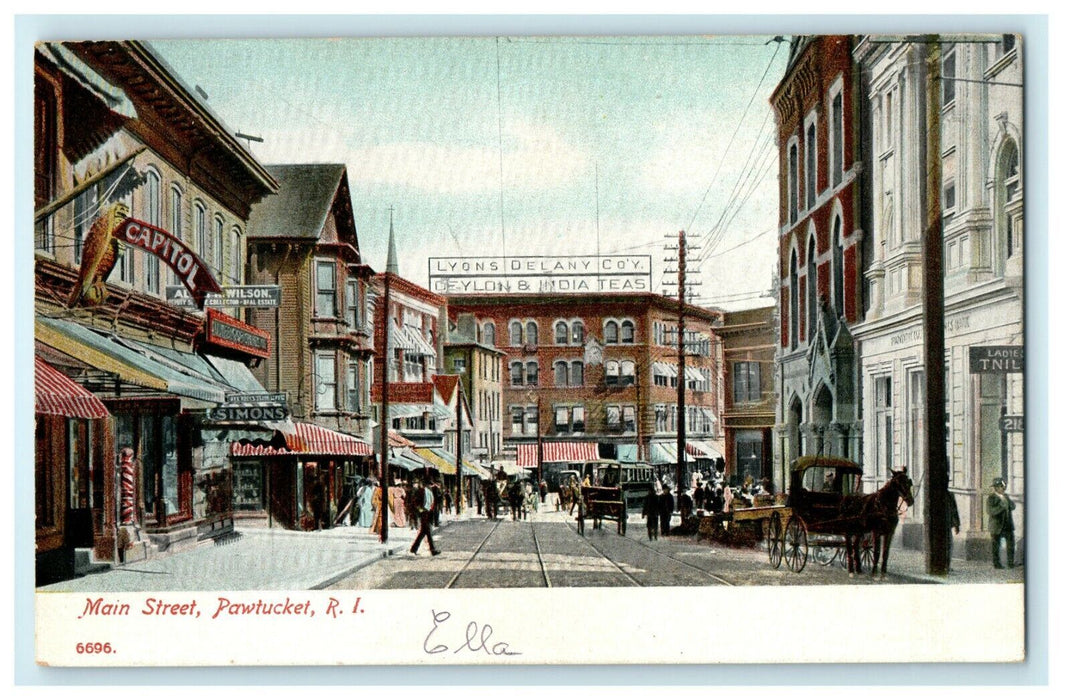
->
[[328, 511, 1022, 590]]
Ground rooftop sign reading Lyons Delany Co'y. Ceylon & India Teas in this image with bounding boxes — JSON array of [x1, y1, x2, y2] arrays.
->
[[427, 255, 652, 294]]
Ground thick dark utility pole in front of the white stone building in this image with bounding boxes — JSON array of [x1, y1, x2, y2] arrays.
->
[[921, 34, 950, 576]]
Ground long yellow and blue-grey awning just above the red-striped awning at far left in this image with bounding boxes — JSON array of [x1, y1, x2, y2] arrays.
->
[[34, 317, 227, 404]]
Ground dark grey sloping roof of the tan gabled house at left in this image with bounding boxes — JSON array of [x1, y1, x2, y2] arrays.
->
[[249, 163, 346, 240]]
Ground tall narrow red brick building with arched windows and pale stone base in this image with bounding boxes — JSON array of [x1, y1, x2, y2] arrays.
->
[[770, 35, 871, 488]]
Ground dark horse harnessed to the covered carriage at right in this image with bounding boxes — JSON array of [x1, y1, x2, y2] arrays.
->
[[840, 468, 914, 578]]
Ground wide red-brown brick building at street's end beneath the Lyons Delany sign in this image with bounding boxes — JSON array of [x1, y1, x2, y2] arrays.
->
[[449, 293, 723, 483]]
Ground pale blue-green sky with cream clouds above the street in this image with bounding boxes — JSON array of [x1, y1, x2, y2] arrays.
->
[[152, 35, 788, 309]]
